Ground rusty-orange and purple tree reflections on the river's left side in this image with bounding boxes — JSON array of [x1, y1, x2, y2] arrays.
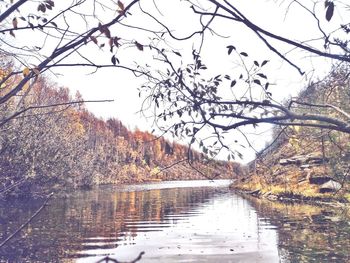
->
[[0, 188, 219, 262]]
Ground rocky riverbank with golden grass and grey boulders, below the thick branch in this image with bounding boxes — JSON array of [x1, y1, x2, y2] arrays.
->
[[231, 130, 350, 206]]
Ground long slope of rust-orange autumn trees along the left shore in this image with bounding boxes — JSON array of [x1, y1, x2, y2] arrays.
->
[[0, 69, 237, 199]]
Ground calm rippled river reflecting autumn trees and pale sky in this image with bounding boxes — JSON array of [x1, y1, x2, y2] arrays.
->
[[0, 180, 350, 263]]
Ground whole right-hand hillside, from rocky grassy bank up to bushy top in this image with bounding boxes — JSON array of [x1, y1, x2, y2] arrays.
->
[[235, 67, 350, 202]]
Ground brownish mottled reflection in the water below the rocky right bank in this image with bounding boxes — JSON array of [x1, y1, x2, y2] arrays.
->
[[249, 198, 350, 262]]
